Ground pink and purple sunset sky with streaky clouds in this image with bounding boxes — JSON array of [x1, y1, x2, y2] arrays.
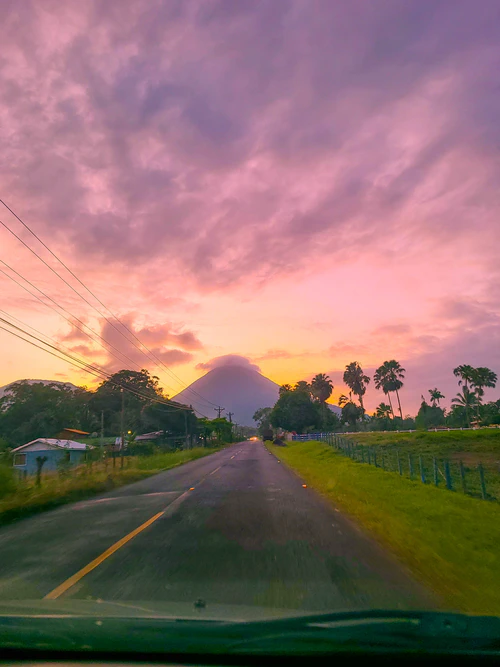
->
[[0, 0, 500, 413]]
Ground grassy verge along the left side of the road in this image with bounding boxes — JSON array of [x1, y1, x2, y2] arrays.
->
[[0, 447, 217, 525]]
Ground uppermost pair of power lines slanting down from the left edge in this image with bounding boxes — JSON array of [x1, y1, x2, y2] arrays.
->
[[0, 198, 221, 405]]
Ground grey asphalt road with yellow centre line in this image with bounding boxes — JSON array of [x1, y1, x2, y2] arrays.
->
[[0, 442, 435, 611]]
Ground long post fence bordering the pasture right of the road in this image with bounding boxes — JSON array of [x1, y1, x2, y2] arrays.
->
[[293, 433, 500, 501]]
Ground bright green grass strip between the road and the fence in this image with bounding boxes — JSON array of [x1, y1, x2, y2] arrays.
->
[[268, 434, 500, 614]]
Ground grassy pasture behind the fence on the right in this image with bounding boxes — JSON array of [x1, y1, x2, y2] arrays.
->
[[345, 429, 500, 500]]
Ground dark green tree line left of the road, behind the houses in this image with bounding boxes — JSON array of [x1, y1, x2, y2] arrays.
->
[[0, 369, 240, 450]]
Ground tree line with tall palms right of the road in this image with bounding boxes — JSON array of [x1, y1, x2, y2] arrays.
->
[[254, 359, 500, 433]]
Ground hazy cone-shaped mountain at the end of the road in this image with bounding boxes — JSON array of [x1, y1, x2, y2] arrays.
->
[[173, 366, 279, 426]]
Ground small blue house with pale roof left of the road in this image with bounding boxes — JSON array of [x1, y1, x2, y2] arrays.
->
[[11, 438, 92, 475]]
